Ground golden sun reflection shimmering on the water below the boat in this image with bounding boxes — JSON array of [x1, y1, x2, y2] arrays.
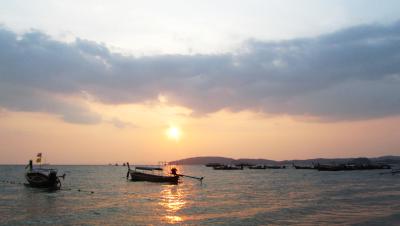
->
[[159, 185, 186, 224]]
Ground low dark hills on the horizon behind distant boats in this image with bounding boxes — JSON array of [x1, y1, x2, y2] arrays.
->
[[170, 156, 400, 165]]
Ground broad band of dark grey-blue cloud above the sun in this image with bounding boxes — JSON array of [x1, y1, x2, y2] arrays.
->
[[0, 23, 400, 123]]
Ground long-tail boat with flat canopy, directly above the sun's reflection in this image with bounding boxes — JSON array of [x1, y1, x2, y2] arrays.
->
[[126, 163, 179, 184]]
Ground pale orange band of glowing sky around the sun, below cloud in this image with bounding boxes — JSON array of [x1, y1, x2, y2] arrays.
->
[[0, 99, 400, 164]]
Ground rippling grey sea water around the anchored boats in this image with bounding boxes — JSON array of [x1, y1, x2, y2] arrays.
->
[[0, 166, 400, 225]]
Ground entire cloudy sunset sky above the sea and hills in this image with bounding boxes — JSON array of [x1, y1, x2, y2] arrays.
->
[[0, 0, 400, 164]]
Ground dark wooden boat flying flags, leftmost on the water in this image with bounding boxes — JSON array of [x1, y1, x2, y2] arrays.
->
[[25, 160, 65, 189]]
